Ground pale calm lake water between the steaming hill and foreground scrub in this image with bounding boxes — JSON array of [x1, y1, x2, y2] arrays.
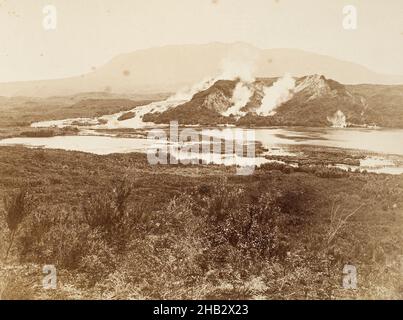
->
[[0, 128, 403, 174]]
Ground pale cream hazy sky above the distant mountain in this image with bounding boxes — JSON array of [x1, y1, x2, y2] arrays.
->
[[0, 0, 403, 81]]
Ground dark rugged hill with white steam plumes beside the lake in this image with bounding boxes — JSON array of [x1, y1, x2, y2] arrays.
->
[[143, 75, 403, 128]]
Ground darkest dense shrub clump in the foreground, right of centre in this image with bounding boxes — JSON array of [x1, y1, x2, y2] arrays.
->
[[189, 185, 312, 263]]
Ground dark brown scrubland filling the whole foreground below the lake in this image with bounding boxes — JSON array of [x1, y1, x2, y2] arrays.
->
[[0, 147, 403, 299]]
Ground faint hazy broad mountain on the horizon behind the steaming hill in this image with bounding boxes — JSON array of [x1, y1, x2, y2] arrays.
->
[[0, 43, 403, 97]]
